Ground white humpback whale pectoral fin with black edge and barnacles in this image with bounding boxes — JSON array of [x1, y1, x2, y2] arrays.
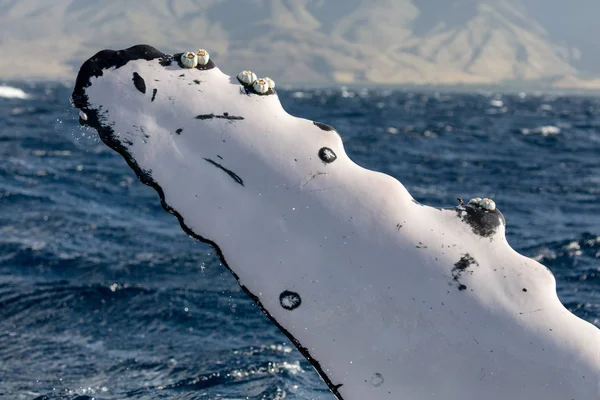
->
[[72, 45, 600, 400]]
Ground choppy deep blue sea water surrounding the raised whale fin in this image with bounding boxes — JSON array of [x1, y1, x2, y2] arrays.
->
[[0, 83, 600, 400]]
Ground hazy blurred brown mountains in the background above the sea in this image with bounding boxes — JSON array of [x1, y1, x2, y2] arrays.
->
[[0, 0, 600, 89]]
